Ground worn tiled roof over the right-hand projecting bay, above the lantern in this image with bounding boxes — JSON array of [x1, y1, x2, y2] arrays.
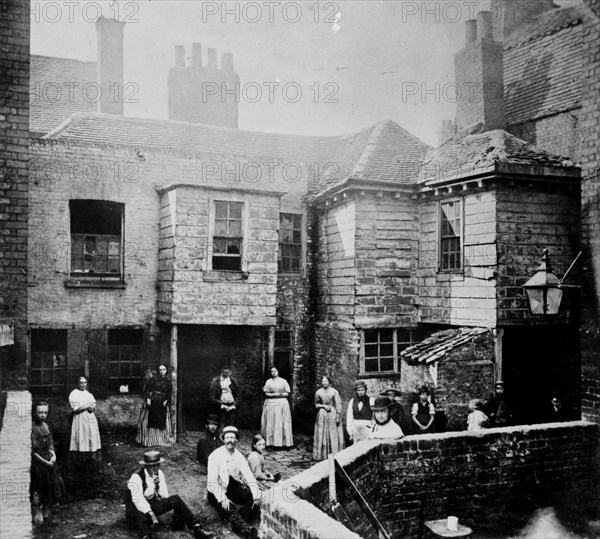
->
[[419, 124, 574, 184]]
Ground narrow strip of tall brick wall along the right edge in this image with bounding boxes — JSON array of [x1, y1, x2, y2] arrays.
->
[[580, 0, 600, 422]]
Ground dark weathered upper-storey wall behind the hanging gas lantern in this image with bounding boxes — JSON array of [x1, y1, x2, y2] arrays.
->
[[496, 181, 580, 325]]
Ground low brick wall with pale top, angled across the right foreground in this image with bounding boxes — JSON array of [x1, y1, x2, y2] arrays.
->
[[262, 421, 599, 539]]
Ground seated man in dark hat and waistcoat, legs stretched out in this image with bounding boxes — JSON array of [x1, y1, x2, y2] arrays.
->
[[125, 451, 214, 539]]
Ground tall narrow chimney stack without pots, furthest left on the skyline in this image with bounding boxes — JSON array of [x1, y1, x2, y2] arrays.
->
[[96, 17, 125, 116]]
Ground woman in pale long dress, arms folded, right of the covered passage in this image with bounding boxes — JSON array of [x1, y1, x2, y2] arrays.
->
[[261, 367, 294, 447]]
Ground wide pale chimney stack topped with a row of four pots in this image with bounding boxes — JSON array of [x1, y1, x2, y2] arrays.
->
[[168, 43, 240, 128]]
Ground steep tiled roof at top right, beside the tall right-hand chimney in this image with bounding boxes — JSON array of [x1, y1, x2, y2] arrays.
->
[[504, 7, 582, 125]]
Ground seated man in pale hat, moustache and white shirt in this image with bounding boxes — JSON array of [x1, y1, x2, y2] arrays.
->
[[206, 427, 260, 539]]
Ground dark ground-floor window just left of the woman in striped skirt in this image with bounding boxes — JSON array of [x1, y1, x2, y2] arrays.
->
[[108, 329, 144, 393]]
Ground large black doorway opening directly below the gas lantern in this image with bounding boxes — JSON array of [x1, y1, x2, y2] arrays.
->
[[502, 325, 580, 424]]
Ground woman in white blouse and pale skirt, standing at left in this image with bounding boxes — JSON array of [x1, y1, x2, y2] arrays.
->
[[69, 376, 101, 464]]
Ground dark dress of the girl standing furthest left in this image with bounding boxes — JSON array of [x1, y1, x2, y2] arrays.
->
[[31, 422, 64, 505]]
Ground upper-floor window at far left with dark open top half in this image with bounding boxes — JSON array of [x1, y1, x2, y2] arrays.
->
[[69, 200, 124, 279]]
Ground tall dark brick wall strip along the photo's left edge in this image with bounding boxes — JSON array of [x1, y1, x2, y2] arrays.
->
[[0, 0, 29, 387]]
